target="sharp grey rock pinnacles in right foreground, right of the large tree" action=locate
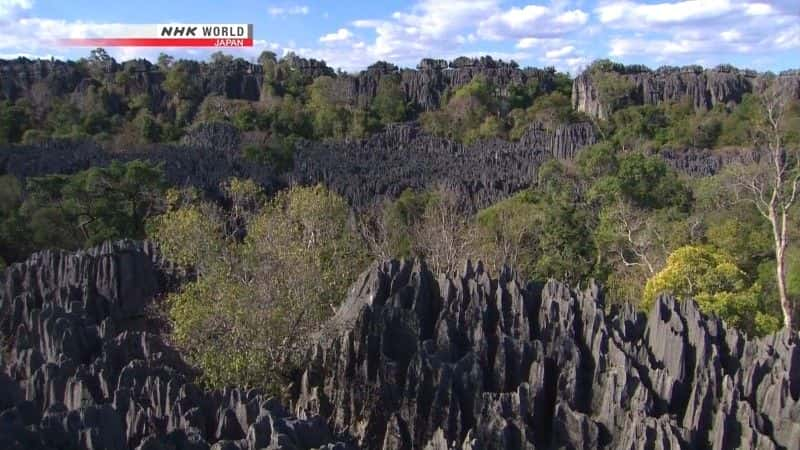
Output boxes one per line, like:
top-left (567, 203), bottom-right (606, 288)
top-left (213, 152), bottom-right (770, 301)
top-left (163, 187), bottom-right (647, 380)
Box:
top-left (294, 261), bottom-right (800, 450)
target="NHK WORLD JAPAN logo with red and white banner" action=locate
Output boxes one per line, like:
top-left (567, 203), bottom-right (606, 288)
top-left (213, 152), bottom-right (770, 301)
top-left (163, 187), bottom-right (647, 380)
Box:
top-left (59, 23), bottom-right (253, 47)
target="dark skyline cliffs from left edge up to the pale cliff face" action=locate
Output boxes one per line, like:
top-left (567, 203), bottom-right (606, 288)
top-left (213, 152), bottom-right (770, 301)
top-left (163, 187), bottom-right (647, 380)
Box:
top-left (0, 55), bottom-right (556, 113)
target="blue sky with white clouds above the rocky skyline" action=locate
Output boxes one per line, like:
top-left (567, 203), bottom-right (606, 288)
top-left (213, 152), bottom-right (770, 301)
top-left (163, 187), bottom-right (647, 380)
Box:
top-left (0, 0), bottom-right (800, 74)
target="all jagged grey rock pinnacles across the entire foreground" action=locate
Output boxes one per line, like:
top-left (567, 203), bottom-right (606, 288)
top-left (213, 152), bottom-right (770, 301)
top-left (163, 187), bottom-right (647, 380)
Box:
top-left (0, 241), bottom-right (800, 450)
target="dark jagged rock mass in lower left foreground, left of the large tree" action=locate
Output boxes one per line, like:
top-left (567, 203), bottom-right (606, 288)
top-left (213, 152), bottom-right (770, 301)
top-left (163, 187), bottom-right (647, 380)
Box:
top-left (0, 241), bottom-right (349, 450)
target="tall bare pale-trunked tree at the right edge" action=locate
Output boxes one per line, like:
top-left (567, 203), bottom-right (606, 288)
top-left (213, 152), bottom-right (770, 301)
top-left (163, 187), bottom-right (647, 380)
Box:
top-left (733, 81), bottom-right (800, 329)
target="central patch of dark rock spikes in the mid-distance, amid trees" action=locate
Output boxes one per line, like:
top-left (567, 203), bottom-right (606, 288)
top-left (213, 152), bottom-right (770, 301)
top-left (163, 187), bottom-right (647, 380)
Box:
top-left (289, 123), bottom-right (597, 209)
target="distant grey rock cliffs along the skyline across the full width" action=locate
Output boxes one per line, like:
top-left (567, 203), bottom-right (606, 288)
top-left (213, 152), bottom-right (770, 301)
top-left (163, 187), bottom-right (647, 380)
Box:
top-left (0, 55), bottom-right (800, 118)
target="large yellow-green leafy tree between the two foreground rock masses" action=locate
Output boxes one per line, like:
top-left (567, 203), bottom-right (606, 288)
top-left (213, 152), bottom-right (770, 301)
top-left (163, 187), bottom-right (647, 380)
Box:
top-left (149, 185), bottom-right (364, 393)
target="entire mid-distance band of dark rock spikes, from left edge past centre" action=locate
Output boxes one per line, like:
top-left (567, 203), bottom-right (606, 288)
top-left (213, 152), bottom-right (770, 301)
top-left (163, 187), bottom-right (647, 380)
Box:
top-left (0, 119), bottom-right (597, 209)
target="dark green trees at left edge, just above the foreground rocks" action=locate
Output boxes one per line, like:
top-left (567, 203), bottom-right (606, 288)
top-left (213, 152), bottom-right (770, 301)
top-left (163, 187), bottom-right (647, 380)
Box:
top-left (0, 161), bottom-right (165, 268)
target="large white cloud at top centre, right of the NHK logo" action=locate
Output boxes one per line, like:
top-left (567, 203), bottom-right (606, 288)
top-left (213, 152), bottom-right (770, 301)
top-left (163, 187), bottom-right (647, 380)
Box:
top-left (310, 0), bottom-right (590, 71)
